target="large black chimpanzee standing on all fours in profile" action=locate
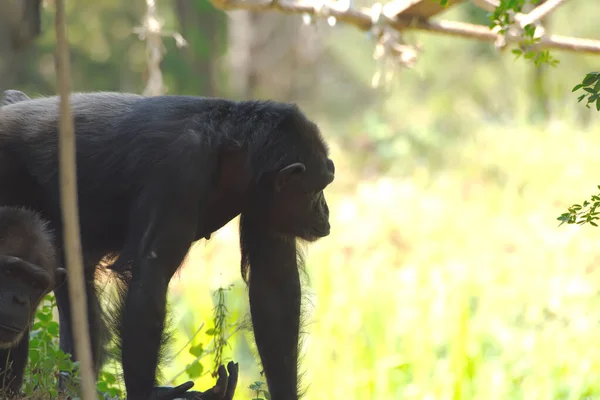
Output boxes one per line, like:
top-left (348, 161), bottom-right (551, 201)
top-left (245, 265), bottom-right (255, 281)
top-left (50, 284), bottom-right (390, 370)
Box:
top-left (0, 93), bottom-right (335, 400)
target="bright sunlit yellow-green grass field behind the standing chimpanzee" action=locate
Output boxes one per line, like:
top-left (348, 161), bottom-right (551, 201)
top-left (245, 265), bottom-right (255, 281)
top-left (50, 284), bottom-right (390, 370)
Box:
top-left (156, 114), bottom-right (600, 400)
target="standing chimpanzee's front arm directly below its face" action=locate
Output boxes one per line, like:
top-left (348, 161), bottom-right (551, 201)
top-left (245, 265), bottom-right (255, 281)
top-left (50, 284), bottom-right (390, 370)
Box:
top-left (240, 216), bottom-right (301, 400)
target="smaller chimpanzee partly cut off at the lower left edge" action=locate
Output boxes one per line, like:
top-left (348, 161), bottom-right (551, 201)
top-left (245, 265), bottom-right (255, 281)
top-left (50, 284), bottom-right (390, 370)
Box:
top-left (0, 207), bottom-right (66, 395)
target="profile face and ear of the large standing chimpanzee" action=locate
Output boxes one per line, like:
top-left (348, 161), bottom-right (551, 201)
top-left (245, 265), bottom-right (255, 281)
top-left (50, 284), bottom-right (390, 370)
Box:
top-left (269, 158), bottom-right (335, 242)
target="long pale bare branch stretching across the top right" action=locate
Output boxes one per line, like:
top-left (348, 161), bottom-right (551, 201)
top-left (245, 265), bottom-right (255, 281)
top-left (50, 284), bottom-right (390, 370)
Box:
top-left (211, 0), bottom-right (600, 54)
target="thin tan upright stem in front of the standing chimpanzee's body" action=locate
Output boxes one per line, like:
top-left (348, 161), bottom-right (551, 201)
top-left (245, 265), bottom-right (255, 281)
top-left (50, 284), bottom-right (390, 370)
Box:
top-left (55, 0), bottom-right (96, 400)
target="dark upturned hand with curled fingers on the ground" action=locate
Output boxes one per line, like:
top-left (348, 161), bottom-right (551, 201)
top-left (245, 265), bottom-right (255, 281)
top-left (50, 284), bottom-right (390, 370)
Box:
top-left (149, 361), bottom-right (239, 400)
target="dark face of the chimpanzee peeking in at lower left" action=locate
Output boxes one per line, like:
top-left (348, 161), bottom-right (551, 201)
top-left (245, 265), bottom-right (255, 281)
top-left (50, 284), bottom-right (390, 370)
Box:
top-left (0, 255), bottom-right (66, 348)
